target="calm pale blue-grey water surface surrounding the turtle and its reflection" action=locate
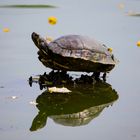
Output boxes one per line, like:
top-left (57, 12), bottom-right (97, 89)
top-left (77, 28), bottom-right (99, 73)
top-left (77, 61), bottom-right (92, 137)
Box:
top-left (0, 0), bottom-right (140, 140)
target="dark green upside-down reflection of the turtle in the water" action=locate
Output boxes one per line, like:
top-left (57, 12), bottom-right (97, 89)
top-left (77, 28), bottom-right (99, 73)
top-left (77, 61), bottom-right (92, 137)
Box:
top-left (30, 81), bottom-right (118, 131)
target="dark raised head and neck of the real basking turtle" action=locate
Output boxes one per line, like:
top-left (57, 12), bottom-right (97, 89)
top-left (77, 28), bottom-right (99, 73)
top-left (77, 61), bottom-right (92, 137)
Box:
top-left (31, 32), bottom-right (48, 50)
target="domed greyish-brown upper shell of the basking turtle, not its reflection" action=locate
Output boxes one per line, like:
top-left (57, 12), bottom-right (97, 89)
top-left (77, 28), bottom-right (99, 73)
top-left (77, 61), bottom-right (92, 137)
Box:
top-left (49, 35), bottom-right (117, 65)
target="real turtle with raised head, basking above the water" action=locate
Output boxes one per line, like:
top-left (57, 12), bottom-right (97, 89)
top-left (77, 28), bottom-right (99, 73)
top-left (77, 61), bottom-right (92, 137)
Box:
top-left (31, 32), bottom-right (118, 80)
